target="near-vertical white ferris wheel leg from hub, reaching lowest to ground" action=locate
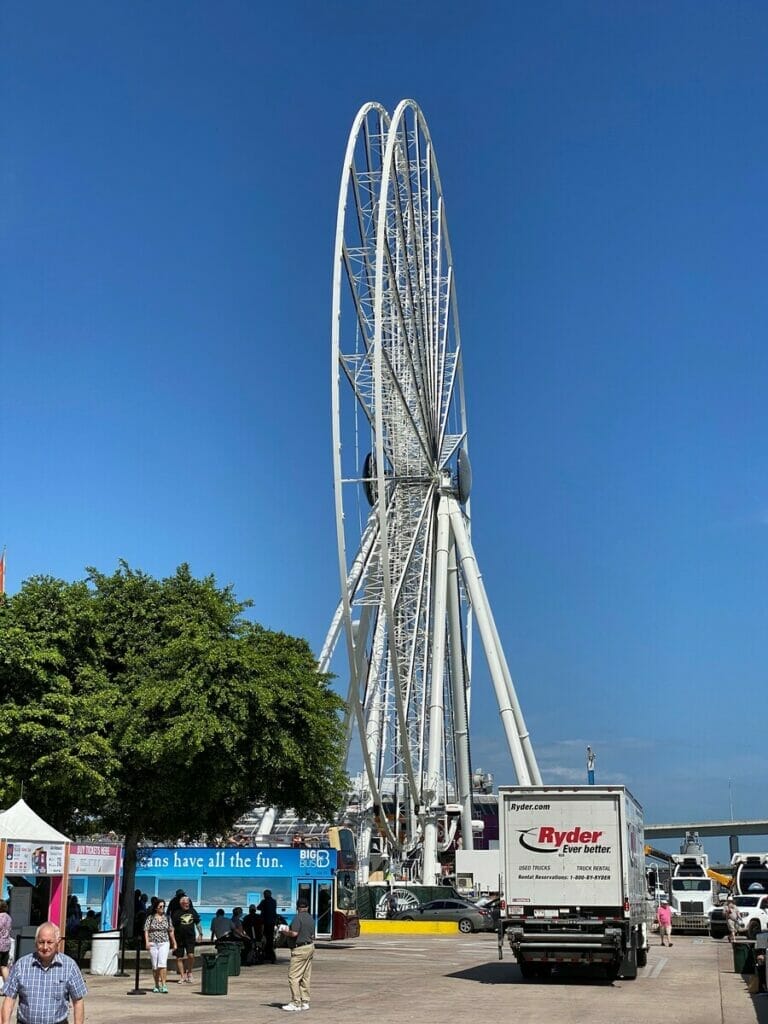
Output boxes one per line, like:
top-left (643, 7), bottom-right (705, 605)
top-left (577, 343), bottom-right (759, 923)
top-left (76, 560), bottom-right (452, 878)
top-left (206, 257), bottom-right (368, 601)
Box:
top-left (422, 495), bottom-right (451, 883)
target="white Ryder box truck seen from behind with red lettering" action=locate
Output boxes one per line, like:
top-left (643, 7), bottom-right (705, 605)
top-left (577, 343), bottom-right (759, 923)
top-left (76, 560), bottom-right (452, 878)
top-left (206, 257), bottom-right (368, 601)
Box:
top-left (499, 785), bottom-right (648, 980)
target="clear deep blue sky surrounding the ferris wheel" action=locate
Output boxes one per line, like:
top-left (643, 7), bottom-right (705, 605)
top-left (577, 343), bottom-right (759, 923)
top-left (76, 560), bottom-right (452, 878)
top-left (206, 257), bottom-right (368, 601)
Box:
top-left (0, 0), bottom-right (768, 855)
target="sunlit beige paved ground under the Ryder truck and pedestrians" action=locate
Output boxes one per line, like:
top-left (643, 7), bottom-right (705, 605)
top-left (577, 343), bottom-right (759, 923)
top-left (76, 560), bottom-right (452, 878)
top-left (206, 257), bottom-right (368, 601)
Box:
top-left (34, 935), bottom-right (768, 1024)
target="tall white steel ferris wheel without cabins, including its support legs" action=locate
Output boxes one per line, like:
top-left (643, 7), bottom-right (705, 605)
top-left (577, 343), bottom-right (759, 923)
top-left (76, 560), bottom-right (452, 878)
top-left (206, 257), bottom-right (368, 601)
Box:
top-left (319, 105), bottom-right (541, 882)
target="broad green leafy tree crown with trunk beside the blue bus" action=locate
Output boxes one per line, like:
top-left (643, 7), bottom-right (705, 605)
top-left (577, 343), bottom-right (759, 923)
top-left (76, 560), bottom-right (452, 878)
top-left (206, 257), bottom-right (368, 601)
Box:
top-left (0, 562), bottom-right (346, 918)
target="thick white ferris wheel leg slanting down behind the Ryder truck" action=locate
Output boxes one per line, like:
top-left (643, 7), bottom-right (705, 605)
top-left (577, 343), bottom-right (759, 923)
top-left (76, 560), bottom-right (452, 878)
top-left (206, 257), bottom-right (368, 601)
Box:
top-left (449, 499), bottom-right (531, 785)
